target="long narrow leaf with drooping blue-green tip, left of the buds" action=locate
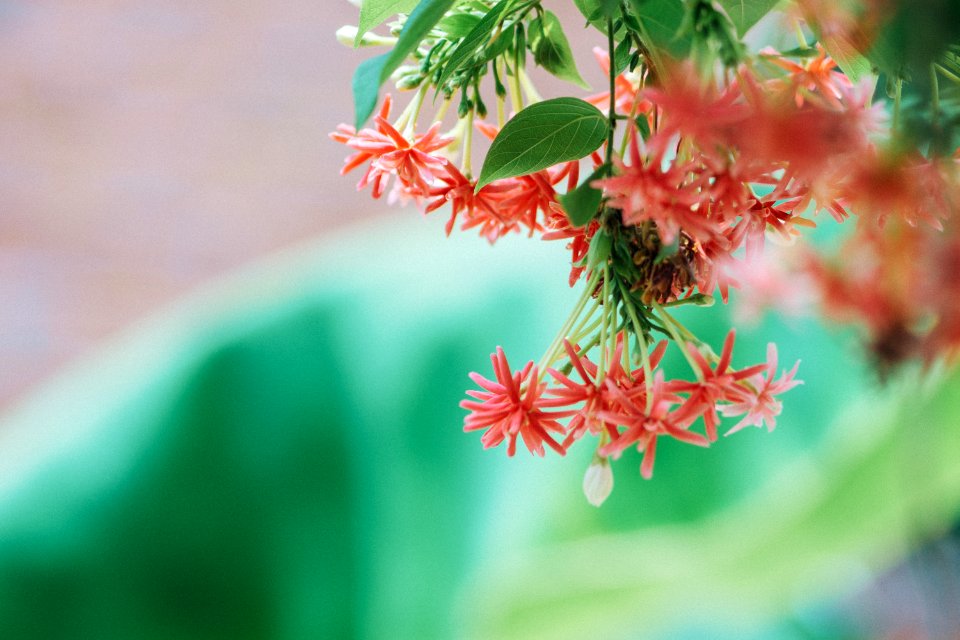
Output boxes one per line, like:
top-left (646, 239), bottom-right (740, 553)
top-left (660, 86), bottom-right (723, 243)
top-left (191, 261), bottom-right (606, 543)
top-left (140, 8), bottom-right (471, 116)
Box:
top-left (353, 0), bottom-right (456, 129)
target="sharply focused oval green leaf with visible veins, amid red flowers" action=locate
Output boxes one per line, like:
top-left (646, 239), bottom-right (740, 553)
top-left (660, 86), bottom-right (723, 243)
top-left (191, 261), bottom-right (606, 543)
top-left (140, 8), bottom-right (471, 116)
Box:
top-left (477, 98), bottom-right (607, 191)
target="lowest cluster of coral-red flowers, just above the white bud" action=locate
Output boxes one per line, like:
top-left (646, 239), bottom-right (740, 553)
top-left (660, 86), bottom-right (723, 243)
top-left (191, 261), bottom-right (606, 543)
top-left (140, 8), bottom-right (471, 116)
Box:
top-left (461, 331), bottom-right (801, 478)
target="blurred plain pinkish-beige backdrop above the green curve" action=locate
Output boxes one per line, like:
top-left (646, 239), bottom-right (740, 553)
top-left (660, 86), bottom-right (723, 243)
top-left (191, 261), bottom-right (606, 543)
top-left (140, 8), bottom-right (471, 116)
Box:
top-left (0, 0), bottom-right (600, 408)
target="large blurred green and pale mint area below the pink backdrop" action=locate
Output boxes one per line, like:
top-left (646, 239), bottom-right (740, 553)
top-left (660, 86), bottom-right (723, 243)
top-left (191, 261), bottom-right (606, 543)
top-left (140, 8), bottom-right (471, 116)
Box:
top-left (0, 216), bottom-right (960, 639)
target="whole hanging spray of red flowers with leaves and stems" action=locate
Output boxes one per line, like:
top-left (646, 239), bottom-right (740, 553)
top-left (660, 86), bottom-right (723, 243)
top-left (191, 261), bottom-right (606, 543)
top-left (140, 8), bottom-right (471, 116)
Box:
top-left (331, 0), bottom-right (960, 504)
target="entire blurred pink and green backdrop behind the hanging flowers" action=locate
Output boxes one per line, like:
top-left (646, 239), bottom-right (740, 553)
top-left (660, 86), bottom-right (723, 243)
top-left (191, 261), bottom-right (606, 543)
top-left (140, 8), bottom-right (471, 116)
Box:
top-left (0, 0), bottom-right (960, 638)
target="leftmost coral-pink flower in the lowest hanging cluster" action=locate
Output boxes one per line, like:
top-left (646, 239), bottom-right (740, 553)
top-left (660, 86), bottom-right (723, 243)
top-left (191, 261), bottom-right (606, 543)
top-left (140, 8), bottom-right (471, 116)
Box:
top-left (460, 347), bottom-right (576, 456)
